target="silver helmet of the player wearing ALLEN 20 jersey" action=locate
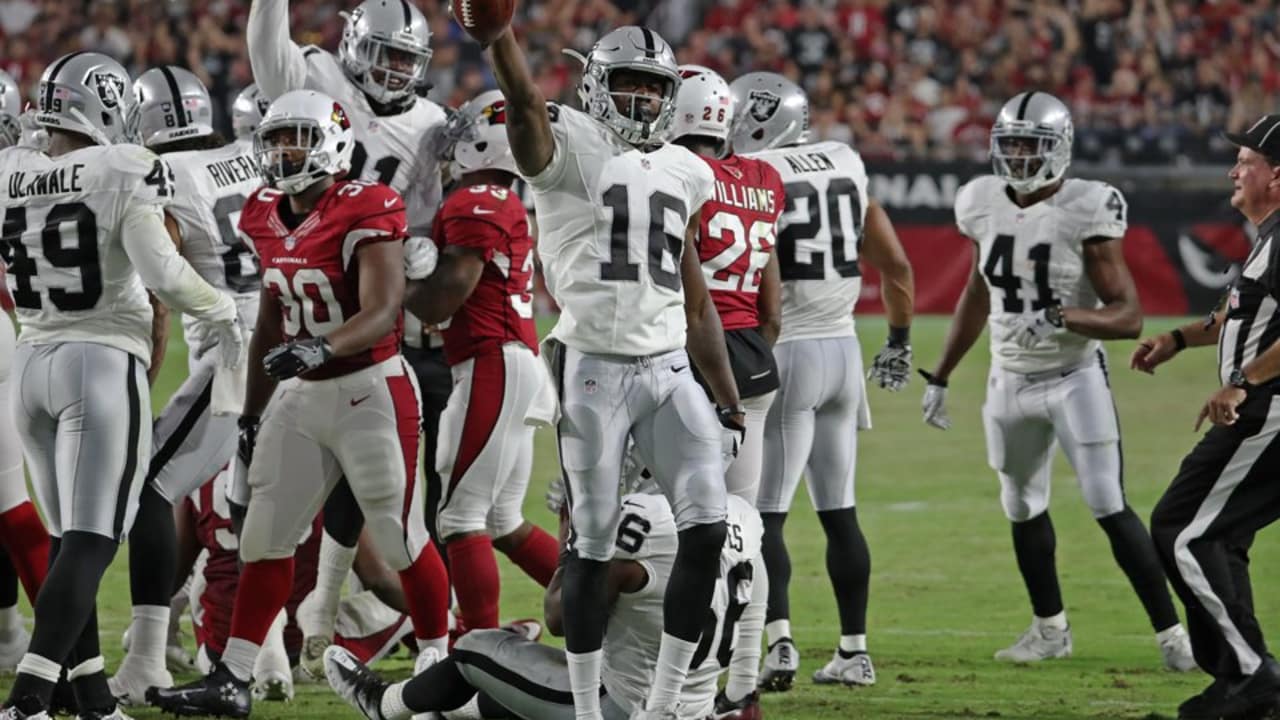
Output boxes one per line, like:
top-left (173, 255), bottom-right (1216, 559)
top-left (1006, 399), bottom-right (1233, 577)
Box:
top-left (728, 73), bottom-right (809, 152)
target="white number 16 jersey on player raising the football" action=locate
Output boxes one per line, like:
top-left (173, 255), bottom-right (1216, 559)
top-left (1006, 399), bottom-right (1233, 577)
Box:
top-left (526, 105), bottom-right (716, 357)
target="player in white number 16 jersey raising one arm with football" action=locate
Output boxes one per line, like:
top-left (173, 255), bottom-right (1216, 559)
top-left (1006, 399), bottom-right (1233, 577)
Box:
top-left (478, 26), bottom-right (746, 719)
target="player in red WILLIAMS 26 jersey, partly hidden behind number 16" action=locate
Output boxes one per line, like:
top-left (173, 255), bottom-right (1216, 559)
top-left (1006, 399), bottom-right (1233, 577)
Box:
top-left (671, 65), bottom-right (783, 506)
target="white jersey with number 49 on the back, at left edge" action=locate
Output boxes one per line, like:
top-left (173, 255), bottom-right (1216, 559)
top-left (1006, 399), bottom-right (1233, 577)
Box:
top-left (0, 145), bottom-right (174, 363)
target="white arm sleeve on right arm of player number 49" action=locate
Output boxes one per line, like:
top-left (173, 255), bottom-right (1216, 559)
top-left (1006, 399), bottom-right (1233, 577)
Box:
top-left (120, 197), bottom-right (236, 322)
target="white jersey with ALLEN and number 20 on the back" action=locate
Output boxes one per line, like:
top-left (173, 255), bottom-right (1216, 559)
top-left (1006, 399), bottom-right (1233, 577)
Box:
top-left (750, 142), bottom-right (868, 342)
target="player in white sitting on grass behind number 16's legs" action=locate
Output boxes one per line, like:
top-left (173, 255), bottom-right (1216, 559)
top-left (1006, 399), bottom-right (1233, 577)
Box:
top-left (325, 495), bottom-right (767, 720)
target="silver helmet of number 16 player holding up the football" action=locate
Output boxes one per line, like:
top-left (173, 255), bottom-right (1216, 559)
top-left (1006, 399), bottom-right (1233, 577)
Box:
top-left (577, 26), bottom-right (680, 147)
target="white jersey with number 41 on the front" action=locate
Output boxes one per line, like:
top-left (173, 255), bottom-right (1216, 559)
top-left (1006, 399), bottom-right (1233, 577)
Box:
top-left (956, 176), bottom-right (1128, 373)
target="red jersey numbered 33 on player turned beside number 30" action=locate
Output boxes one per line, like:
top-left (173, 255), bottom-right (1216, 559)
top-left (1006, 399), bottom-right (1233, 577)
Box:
top-left (434, 184), bottom-right (538, 365)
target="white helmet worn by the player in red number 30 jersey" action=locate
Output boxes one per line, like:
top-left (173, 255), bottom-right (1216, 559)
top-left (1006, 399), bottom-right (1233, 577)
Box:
top-left (253, 90), bottom-right (356, 195)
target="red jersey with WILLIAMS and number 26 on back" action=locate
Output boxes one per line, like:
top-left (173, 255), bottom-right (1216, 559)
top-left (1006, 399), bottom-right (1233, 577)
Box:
top-left (698, 155), bottom-right (786, 331)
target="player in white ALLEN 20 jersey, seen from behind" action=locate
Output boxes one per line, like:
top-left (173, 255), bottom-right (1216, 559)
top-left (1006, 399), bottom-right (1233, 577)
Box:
top-left (731, 73), bottom-right (914, 691)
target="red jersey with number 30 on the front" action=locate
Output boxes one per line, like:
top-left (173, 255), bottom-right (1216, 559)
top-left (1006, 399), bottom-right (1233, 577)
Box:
top-left (239, 181), bottom-right (408, 380)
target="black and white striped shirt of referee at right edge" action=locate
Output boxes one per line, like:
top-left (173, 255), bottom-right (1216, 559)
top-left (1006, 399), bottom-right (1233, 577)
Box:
top-left (1217, 210), bottom-right (1280, 384)
